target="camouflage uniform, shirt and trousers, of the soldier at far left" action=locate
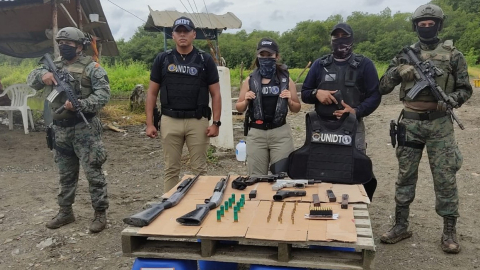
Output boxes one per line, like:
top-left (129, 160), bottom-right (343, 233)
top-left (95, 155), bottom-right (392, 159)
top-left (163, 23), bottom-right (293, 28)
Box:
top-left (27, 55), bottom-right (110, 211)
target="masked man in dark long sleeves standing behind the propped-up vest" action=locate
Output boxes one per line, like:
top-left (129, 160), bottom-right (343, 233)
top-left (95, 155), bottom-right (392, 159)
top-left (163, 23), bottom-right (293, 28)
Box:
top-left (302, 23), bottom-right (381, 199)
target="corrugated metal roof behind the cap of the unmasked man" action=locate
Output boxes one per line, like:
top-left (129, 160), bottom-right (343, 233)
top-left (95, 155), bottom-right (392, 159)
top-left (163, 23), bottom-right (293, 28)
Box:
top-left (145, 6), bottom-right (242, 31)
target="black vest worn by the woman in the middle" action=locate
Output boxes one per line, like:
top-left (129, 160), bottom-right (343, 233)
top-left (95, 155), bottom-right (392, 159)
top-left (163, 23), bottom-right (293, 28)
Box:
top-left (249, 69), bottom-right (290, 125)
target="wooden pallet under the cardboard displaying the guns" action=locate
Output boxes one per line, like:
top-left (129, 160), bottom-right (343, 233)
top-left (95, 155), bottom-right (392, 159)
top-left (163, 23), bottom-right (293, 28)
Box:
top-left (122, 204), bottom-right (375, 270)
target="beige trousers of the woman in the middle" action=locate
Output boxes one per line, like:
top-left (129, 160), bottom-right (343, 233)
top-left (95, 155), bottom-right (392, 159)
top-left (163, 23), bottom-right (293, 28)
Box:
top-left (247, 124), bottom-right (294, 175)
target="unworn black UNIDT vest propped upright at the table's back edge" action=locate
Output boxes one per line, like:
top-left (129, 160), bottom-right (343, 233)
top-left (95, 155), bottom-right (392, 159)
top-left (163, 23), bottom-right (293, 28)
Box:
top-left (288, 112), bottom-right (373, 184)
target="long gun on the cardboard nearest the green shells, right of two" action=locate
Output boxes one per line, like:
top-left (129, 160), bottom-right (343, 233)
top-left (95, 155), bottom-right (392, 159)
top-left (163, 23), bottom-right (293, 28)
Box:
top-left (177, 175), bottom-right (230, 226)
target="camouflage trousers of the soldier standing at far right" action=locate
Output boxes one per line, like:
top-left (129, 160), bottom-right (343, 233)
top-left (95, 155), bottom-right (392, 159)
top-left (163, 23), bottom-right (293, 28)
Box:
top-left (395, 117), bottom-right (463, 217)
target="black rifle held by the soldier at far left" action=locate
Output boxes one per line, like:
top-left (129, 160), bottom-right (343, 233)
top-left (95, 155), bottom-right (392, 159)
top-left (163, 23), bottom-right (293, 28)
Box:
top-left (40, 53), bottom-right (92, 128)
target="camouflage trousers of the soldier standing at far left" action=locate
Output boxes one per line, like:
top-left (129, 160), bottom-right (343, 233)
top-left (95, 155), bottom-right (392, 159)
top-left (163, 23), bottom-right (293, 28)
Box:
top-left (53, 117), bottom-right (108, 211)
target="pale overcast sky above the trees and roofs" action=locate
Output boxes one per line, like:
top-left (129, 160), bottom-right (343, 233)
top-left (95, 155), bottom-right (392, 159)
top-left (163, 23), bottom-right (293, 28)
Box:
top-left (100, 0), bottom-right (428, 40)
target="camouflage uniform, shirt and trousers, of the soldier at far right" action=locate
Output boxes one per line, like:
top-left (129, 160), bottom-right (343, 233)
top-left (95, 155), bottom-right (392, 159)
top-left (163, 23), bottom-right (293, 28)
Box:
top-left (380, 42), bottom-right (472, 217)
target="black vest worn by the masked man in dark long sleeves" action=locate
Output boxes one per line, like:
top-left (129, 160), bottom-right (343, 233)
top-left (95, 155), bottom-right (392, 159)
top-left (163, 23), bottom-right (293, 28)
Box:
top-left (315, 54), bottom-right (365, 117)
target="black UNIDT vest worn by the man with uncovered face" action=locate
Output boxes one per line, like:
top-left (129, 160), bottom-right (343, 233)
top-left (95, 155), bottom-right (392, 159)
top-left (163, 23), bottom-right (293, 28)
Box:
top-left (160, 50), bottom-right (209, 114)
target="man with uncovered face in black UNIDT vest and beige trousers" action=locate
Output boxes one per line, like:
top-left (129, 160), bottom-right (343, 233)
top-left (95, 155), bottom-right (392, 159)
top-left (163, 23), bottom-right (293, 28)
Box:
top-left (145, 17), bottom-right (222, 192)
